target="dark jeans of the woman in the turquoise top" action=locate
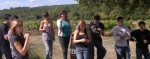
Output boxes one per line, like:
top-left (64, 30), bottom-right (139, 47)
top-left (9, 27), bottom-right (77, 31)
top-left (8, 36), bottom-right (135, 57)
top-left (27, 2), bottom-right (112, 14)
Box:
top-left (59, 36), bottom-right (70, 59)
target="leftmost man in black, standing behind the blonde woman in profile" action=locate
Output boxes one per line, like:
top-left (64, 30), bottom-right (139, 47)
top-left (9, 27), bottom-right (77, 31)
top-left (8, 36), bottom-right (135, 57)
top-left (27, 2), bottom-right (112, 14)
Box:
top-left (0, 14), bottom-right (12, 59)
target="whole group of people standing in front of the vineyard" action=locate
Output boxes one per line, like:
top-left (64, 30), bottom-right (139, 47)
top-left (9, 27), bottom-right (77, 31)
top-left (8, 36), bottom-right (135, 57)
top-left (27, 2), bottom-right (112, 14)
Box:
top-left (0, 11), bottom-right (150, 59)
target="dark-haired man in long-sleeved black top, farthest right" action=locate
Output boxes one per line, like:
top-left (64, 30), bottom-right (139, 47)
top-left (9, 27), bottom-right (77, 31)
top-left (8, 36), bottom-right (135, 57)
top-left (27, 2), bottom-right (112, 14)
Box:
top-left (131, 21), bottom-right (150, 59)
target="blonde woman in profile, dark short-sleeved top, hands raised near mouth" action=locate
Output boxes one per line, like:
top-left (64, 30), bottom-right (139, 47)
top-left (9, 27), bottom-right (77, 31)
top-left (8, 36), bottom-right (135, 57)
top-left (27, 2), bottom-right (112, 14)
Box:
top-left (10, 19), bottom-right (30, 59)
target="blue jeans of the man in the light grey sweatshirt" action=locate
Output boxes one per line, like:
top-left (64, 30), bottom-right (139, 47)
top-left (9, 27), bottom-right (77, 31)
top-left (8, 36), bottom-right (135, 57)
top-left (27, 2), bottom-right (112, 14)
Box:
top-left (115, 46), bottom-right (130, 59)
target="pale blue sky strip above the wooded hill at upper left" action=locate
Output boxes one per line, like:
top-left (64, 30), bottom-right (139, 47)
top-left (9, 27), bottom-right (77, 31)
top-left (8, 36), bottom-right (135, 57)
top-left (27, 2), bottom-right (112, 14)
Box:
top-left (0, 0), bottom-right (77, 10)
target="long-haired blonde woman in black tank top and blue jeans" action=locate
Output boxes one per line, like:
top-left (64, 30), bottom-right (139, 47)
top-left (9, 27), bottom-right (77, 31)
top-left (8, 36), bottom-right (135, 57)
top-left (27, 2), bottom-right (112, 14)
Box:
top-left (73, 21), bottom-right (91, 59)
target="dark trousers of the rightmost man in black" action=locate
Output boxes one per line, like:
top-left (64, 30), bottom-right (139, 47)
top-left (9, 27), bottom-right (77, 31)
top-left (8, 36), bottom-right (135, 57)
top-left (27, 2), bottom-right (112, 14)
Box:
top-left (136, 47), bottom-right (150, 59)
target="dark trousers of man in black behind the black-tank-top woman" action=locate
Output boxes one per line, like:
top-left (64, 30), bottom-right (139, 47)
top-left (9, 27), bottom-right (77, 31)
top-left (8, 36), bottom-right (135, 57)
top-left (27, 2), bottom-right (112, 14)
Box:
top-left (93, 37), bottom-right (106, 59)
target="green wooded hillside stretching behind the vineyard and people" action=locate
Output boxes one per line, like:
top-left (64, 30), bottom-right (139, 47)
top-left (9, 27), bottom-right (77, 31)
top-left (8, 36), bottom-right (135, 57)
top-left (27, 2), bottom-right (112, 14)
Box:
top-left (0, 4), bottom-right (150, 20)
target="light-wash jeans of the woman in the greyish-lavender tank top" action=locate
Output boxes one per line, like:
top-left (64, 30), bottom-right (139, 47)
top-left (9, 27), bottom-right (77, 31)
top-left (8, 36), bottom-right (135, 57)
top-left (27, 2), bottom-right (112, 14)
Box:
top-left (43, 40), bottom-right (53, 59)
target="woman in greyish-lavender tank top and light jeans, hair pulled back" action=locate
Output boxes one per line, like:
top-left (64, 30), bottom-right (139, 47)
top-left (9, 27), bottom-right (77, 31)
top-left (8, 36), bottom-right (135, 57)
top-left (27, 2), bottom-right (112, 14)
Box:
top-left (39, 12), bottom-right (55, 59)
